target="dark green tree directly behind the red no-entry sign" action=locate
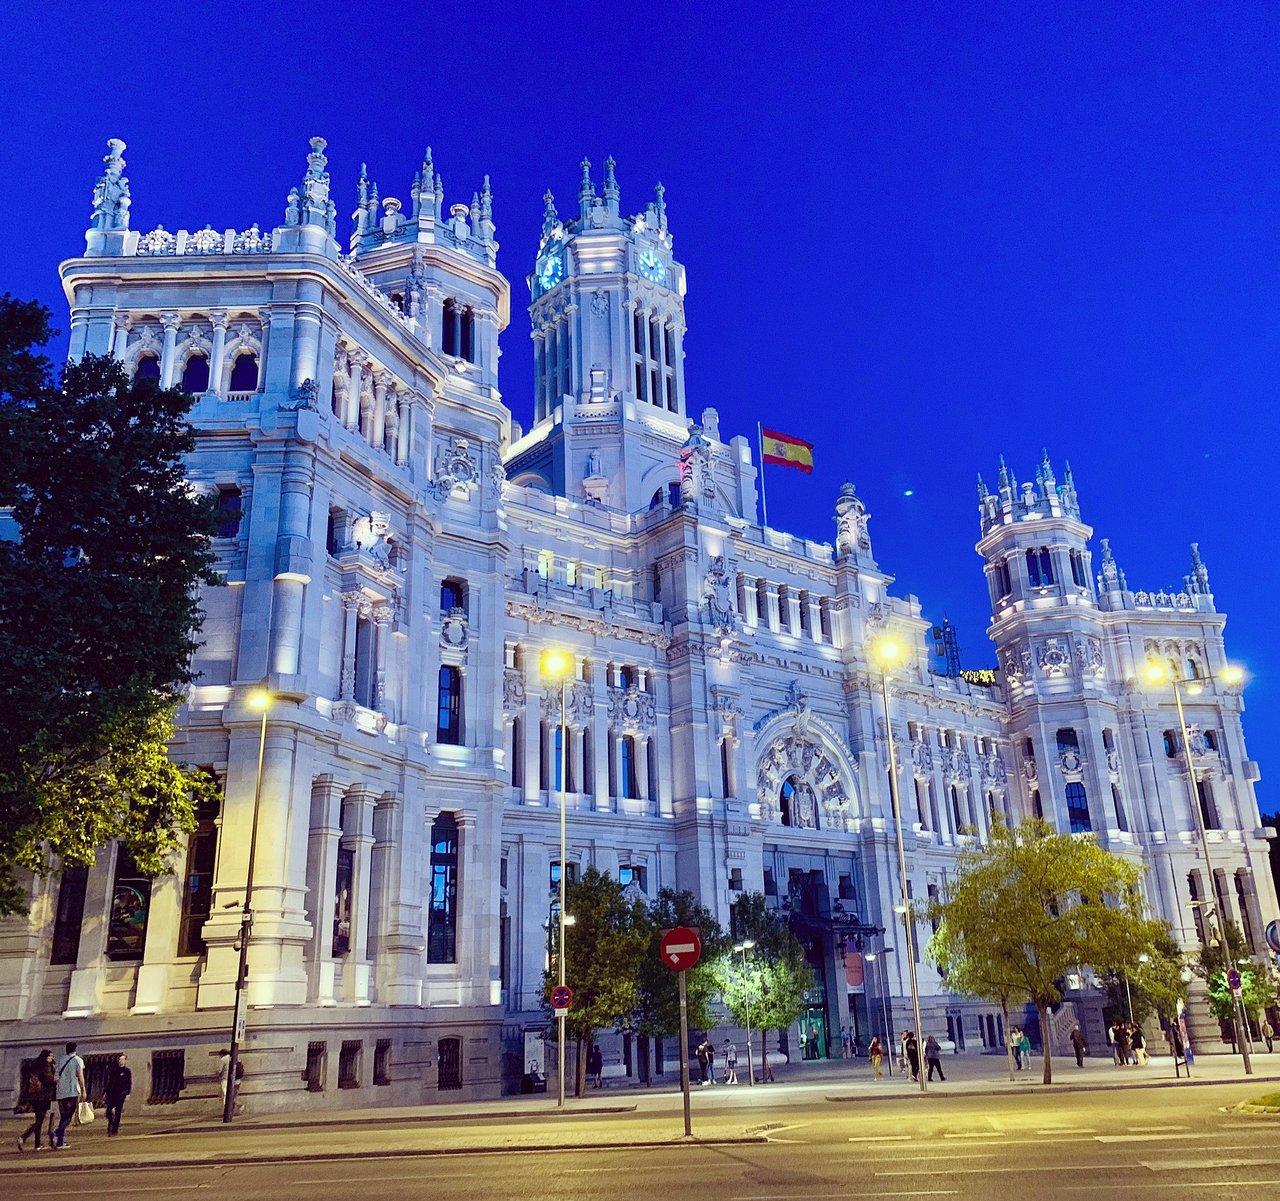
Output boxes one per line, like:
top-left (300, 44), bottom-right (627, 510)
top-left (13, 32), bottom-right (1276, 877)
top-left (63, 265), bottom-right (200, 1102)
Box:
top-left (632, 889), bottom-right (728, 1083)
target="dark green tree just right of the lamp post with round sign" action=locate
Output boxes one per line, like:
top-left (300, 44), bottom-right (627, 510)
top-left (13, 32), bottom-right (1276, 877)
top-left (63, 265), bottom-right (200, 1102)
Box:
top-left (543, 867), bottom-right (652, 1096)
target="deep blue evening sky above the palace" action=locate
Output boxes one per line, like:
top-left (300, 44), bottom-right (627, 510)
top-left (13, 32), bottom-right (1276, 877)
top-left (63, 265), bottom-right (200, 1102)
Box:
top-left (0, 7), bottom-right (1280, 808)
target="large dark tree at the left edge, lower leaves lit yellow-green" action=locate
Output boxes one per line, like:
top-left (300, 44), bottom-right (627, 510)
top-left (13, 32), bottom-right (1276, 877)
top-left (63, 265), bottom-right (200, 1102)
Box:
top-left (0, 296), bottom-right (215, 913)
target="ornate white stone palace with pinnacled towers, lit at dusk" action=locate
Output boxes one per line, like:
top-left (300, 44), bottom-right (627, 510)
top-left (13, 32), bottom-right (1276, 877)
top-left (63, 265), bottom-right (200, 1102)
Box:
top-left (0, 138), bottom-right (1277, 1110)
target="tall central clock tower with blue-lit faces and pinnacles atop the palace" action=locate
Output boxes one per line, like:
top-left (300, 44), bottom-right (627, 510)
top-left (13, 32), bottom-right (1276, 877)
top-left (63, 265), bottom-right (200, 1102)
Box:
top-left (507, 157), bottom-right (689, 511)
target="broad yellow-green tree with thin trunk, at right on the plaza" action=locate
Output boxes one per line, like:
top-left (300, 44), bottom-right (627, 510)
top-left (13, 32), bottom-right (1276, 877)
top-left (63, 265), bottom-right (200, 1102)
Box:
top-left (925, 821), bottom-right (1164, 1084)
